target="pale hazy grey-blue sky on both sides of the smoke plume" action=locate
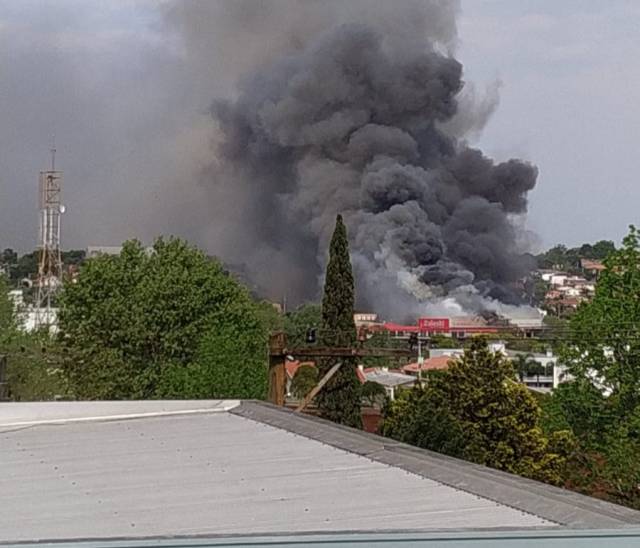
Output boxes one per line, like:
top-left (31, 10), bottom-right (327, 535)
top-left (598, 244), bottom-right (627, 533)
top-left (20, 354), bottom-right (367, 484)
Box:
top-left (0, 0), bottom-right (640, 251)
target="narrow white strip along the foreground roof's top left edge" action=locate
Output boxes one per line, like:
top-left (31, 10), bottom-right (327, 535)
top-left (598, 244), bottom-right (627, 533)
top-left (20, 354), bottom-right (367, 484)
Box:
top-left (0, 400), bottom-right (240, 431)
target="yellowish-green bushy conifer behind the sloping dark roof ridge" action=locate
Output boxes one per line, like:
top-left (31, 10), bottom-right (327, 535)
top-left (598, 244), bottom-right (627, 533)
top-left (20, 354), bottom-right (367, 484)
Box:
top-left (382, 339), bottom-right (570, 484)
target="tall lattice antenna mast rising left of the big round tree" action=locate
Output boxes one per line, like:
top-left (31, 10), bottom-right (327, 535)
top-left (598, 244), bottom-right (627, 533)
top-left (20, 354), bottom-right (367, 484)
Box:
top-left (35, 140), bottom-right (64, 328)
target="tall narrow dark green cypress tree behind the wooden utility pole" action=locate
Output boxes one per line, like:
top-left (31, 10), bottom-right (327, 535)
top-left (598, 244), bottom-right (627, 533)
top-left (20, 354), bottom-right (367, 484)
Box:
top-left (316, 215), bottom-right (362, 428)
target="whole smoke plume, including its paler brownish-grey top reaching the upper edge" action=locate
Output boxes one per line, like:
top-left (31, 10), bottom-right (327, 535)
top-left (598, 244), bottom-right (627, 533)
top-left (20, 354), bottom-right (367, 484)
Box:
top-left (167, 1), bottom-right (537, 318)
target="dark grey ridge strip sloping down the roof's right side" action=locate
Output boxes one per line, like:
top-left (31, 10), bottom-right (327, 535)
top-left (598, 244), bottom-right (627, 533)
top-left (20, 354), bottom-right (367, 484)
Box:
top-left (230, 401), bottom-right (640, 529)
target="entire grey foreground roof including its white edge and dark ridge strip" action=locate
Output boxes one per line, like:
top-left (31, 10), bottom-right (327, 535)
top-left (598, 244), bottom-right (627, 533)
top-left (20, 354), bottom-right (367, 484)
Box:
top-left (0, 401), bottom-right (640, 546)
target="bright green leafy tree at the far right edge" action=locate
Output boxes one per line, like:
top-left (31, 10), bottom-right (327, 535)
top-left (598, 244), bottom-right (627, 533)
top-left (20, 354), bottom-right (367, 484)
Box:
top-left (544, 227), bottom-right (640, 508)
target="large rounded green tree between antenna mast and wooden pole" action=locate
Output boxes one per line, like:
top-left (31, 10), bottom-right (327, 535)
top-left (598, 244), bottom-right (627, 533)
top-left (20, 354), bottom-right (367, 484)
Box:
top-left (60, 239), bottom-right (266, 399)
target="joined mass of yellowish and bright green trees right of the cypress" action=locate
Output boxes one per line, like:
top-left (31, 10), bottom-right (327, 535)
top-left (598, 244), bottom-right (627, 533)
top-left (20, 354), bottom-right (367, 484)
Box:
top-left (382, 227), bottom-right (640, 509)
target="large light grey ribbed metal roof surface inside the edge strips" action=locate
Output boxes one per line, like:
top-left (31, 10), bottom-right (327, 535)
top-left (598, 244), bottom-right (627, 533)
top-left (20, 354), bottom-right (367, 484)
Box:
top-left (0, 406), bottom-right (553, 541)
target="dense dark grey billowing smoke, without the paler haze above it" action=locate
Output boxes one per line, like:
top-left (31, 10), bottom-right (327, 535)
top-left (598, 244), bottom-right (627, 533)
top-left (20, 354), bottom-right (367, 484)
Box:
top-left (204, 9), bottom-right (537, 317)
